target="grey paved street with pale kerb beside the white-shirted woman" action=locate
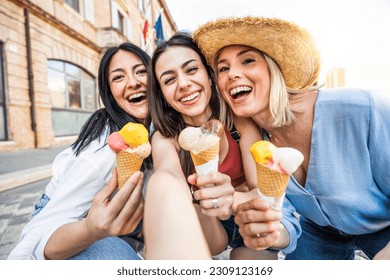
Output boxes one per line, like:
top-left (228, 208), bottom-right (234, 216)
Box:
top-left (0, 146), bottom-right (67, 260)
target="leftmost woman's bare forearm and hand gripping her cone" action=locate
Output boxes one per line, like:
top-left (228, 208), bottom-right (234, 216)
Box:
top-left (44, 172), bottom-right (144, 259)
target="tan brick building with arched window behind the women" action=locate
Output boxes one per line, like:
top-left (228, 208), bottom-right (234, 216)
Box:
top-left (0, 0), bottom-right (177, 152)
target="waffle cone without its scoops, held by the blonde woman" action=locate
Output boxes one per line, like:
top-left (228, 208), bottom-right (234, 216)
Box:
top-left (256, 162), bottom-right (290, 197)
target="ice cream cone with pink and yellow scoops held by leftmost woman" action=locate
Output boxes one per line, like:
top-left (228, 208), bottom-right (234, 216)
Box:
top-left (108, 122), bottom-right (151, 188)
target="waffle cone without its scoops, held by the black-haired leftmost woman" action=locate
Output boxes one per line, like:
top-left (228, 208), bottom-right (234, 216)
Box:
top-left (116, 150), bottom-right (143, 188)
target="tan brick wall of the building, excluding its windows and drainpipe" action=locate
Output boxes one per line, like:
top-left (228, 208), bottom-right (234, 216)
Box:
top-left (0, 0), bottom-right (176, 152)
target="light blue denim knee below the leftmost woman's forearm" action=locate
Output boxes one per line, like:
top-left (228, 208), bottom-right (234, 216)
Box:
top-left (68, 236), bottom-right (141, 260)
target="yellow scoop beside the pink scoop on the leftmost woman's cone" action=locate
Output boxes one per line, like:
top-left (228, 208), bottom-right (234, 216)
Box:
top-left (119, 122), bottom-right (149, 148)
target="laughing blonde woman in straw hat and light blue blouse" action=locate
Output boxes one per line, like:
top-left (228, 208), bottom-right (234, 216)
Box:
top-left (194, 17), bottom-right (390, 259)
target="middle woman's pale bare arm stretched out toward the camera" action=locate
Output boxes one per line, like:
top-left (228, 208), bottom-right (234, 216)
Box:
top-left (144, 171), bottom-right (211, 260)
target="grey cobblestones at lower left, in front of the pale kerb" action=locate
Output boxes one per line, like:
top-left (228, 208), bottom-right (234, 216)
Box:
top-left (0, 179), bottom-right (49, 260)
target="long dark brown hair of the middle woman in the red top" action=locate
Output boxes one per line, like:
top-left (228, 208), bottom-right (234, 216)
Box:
top-left (147, 31), bottom-right (232, 176)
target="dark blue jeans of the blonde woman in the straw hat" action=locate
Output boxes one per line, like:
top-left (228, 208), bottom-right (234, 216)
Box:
top-left (285, 216), bottom-right (390, 260)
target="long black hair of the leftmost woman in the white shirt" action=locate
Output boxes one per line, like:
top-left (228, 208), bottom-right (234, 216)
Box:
top-left (72, 42), bottom-right (150, 168)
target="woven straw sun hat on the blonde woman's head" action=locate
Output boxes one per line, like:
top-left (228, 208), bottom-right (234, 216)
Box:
top-left (193, 16), bottom-right (321, 89)
